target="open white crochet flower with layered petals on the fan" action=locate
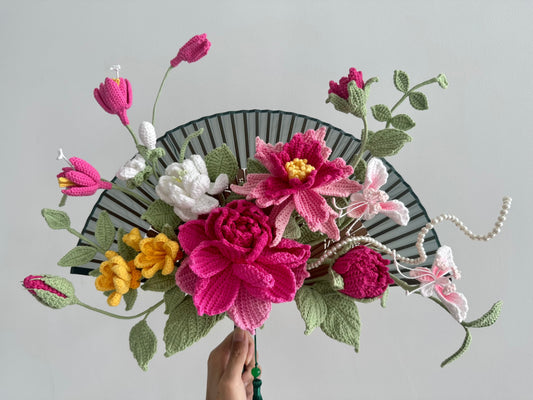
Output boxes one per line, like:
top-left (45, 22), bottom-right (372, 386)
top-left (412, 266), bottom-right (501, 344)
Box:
top-left (155, 155), bottom-right (229, 221)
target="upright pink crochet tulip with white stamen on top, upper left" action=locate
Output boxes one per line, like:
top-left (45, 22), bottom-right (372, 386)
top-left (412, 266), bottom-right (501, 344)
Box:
top-left (94, 78), bottom-right (132, 125)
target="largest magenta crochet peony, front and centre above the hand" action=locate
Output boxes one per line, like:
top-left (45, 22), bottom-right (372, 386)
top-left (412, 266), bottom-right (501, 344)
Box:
top-left (176, 200), bottom-right (310, 332)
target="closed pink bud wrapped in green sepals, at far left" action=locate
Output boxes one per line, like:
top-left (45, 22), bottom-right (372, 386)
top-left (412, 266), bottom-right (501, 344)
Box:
top-left (22, 275), bottom-right (78, 308)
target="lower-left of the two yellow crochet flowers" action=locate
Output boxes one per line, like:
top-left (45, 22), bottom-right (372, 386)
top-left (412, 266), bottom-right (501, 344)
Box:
top-left (94, 250), bottom-right (142, 307)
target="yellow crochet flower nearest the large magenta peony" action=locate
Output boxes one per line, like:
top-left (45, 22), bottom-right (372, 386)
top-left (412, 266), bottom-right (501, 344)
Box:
top-left (134, 233), bottom-right (183, 279)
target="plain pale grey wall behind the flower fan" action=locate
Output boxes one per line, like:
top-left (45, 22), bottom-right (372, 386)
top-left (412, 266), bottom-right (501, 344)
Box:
top-left (0, 0), bottom-right (533, 400)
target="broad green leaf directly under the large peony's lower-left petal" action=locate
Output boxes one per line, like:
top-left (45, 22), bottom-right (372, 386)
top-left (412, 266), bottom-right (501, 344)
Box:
top-left (163, 296), bottom-right (224, 357)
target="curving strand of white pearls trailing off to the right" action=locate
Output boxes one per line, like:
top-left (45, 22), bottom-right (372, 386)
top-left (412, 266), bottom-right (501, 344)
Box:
top-left (307, 196), bottom-right (512, 271)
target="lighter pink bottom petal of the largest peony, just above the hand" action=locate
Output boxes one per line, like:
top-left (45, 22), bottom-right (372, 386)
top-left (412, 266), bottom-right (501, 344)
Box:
top-left (228, 290), bottom-right (272, 334)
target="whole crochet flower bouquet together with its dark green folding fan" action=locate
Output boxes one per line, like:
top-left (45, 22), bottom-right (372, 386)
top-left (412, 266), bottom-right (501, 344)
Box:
top-left (23, 35), bottom-right (510, 372)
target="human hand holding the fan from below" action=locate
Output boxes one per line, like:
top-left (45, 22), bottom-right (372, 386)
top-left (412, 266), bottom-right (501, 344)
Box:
top-left (206, 328), bottom-right (255, 400)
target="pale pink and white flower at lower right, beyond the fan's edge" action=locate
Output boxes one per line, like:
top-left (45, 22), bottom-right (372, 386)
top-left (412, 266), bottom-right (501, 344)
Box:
top-left (410, 246), bottom-right (468, 322)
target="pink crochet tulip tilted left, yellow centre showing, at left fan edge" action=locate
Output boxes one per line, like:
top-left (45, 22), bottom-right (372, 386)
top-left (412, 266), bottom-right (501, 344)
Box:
top-left (57, 157), bottom-right (112, 196)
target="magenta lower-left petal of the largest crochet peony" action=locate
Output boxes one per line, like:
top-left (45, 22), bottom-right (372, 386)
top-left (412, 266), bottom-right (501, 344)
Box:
top-left (193, 269), bottom-right (241, 315)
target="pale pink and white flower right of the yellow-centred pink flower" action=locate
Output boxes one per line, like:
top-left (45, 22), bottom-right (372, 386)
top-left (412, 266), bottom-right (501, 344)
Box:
top-left (348, 158), bottom-right (409, 225)
